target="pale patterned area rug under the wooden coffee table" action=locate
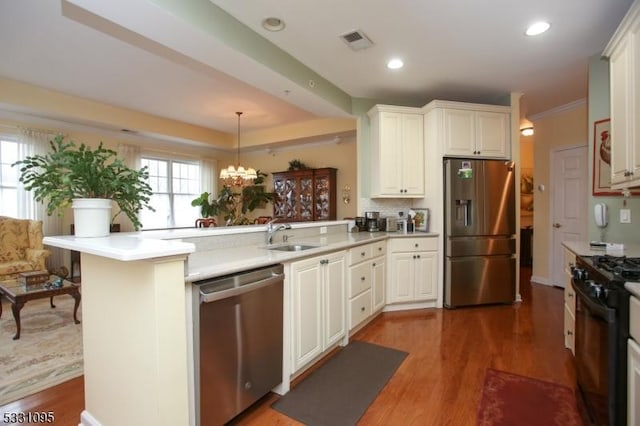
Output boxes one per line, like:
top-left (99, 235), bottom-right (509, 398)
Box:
top-left (0, 295), bottom-right (83, 405)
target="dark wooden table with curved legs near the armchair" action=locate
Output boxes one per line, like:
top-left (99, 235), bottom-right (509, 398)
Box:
top-left (0, 275), bottom-right (80, 340)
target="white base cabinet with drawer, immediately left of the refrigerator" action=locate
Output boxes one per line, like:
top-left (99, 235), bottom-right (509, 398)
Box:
top-left (387, 237), bottom-right (438, 303)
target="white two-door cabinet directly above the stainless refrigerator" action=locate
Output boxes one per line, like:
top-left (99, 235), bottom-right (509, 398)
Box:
top-left (436, 101), bottom-right (511, 158)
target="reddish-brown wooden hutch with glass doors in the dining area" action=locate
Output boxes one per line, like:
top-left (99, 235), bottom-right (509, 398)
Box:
top-left (273, 168), bottom-right (337, 222)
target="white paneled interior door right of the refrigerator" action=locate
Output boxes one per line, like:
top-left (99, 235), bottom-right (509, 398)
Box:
top-left (549, 146), bottom-right (591, 287)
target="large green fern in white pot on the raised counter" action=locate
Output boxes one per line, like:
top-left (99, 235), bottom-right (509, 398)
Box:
top-left (13, 135), bottom-right (153, 237)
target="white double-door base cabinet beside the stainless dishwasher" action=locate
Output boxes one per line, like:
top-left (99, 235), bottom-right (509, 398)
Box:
top-left (290, 251), bottom-right (346, 372)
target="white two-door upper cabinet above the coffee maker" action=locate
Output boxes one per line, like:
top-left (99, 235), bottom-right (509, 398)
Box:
top-left (368, 105), bottom-right (424, 198)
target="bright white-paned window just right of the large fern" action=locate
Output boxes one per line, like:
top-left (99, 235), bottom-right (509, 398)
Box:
top-left (140, 157), bottom-right (200, 229)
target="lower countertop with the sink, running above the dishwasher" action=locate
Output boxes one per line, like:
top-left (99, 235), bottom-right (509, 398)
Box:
top-left (185, 232), bottom-right (438, 282)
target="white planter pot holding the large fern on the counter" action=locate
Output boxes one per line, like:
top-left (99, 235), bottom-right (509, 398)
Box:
top-left (71, 198), bottom-right (111, 238)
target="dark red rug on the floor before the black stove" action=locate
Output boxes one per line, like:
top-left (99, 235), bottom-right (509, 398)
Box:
top-left (478, 368), bottom-right (583, 426)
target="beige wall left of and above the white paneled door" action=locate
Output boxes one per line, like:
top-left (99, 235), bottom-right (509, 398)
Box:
top-left (532, 103), bottom-right (589, 282)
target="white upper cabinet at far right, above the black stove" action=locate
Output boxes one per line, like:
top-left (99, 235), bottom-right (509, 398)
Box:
top-left (596, 2), bottom-right (640, 189)
